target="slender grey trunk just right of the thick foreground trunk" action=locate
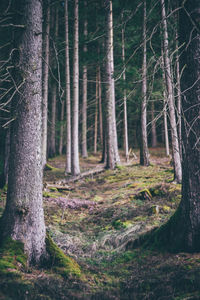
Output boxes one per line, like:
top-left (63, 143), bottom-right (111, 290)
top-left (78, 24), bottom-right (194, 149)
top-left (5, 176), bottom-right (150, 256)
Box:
top-left (42, 0), bottom-right (50, 167)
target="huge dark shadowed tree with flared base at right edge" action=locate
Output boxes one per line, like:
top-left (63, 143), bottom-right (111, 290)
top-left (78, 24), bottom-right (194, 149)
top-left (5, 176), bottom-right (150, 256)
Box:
top-left (149, 0), bottom-right (200, 252)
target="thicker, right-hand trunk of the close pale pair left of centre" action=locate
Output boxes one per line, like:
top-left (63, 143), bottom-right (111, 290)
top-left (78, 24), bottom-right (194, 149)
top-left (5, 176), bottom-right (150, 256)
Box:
top-left (72, 0), bottom-right (80, 176)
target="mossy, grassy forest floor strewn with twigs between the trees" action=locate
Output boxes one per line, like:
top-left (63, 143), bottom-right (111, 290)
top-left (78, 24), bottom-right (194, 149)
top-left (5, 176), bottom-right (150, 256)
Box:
top-left (0, 148), bottom-right (200, 300)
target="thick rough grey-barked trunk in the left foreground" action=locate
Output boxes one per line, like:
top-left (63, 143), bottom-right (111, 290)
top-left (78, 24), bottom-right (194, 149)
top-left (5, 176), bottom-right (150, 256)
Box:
top-left (1, 0), bottom-right (46, 263)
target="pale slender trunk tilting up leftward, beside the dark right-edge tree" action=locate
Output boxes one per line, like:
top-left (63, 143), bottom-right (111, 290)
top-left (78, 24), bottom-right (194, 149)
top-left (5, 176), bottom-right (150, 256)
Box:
top-left (161, 0), bottom-right (182, 183)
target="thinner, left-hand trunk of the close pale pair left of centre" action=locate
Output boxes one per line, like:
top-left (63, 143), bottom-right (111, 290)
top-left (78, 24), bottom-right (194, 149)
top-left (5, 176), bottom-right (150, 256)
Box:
top-left (65, 0), bottom-right (72, 174)
